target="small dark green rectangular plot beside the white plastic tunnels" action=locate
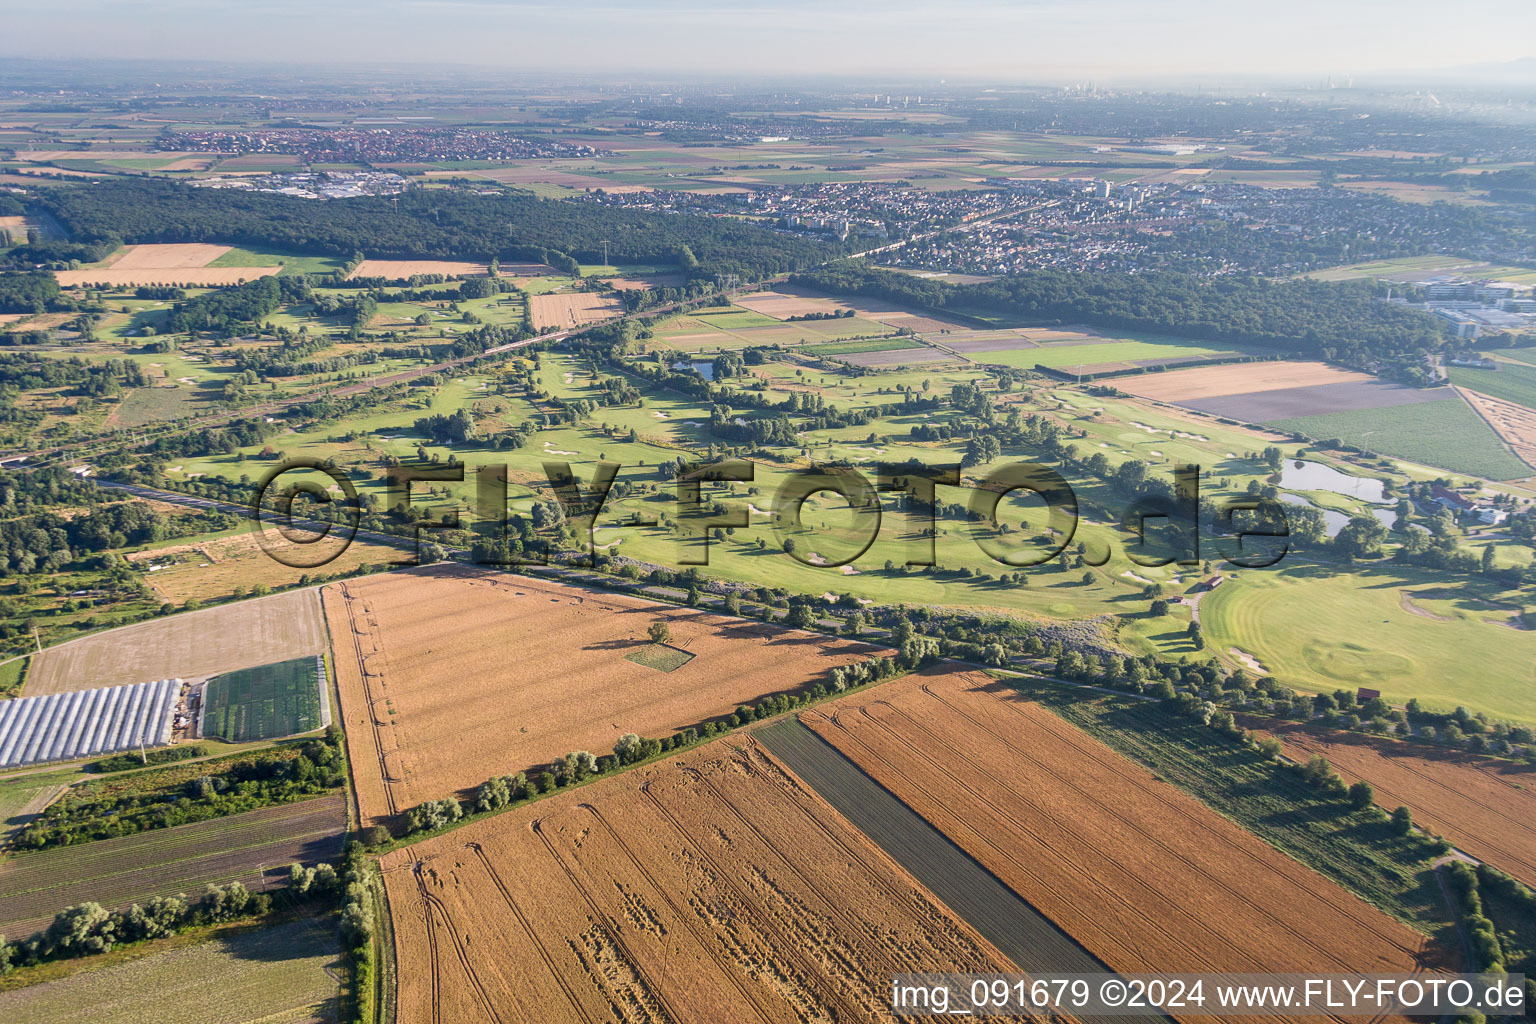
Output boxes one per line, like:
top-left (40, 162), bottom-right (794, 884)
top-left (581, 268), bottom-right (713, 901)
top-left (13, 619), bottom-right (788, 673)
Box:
top-left (203, 657), bottom-right (324, 743)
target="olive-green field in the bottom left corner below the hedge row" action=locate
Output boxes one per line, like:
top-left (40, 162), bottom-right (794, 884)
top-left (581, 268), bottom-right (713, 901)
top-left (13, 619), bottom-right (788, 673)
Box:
top-left (0, 918), bottom-right (343, 1024)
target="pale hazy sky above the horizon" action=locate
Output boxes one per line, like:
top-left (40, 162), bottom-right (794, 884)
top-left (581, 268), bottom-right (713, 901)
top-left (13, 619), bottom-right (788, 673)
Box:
top-left (0, 0), bottom-right (1536, 81)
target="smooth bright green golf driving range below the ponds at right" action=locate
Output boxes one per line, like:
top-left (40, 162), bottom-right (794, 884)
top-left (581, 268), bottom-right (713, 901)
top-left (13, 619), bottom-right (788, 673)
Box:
top-left (1200, 563), bottom-right (1536, 723)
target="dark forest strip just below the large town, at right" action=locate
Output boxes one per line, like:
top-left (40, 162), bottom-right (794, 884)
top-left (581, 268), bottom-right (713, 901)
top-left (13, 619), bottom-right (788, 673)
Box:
top-left (791, 263), bottom-right (1442, 382)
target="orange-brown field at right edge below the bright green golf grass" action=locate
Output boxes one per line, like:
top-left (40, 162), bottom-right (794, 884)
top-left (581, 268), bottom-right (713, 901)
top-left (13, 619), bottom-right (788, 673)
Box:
top-left (1256, 722), bottom-right (1536, 886)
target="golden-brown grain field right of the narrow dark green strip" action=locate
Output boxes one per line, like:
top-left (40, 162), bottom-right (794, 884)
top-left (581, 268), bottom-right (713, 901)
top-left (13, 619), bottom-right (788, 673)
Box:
top-left (800, 666), bottom-right (1427, 1019)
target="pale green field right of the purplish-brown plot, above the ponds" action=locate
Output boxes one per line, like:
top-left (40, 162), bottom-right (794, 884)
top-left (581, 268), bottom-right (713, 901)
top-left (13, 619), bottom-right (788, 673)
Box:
top-left (1264, 399), bottom-right (1531, 481)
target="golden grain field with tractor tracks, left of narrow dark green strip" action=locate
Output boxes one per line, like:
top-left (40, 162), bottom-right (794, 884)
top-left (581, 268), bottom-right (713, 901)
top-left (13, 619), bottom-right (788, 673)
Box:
top-left (382, 738), bottom-right (1014, 1024)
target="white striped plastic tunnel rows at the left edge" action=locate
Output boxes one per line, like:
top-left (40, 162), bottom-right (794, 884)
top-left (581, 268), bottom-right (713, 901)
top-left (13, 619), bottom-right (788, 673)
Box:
top-left (0, 679), bottom-right (181, 768)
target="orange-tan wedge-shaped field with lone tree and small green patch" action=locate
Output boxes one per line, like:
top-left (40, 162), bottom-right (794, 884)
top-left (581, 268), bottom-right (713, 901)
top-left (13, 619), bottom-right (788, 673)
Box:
top-left (323, 567), bottom-right (879, 823)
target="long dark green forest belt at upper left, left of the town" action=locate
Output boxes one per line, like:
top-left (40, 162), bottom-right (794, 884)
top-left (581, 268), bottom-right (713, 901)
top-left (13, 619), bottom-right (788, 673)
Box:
top-left (29, 180), bottom-right (839, 279)
